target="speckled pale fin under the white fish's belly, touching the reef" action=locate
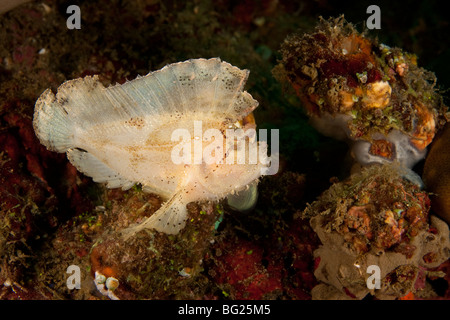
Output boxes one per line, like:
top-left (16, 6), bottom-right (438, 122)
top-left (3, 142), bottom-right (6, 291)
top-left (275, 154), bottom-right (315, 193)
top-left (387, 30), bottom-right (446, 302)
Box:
top-left (123, 191), bottom-right (188, 239)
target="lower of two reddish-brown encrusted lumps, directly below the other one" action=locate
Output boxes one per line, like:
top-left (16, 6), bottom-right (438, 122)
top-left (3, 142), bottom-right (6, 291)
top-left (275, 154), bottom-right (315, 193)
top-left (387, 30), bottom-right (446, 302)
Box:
top-left (303, 165), bottom-right (450, 299)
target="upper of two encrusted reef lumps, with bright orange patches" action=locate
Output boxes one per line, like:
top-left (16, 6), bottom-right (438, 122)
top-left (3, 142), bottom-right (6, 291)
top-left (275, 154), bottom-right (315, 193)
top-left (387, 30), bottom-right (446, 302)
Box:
top-left (274, 16), bottom-right (447, 167)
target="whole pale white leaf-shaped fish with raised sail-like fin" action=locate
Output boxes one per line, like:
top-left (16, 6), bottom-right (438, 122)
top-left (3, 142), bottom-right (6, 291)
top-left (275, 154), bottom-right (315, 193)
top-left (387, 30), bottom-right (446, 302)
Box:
top-left (33, 58), bottom-right (270, 237)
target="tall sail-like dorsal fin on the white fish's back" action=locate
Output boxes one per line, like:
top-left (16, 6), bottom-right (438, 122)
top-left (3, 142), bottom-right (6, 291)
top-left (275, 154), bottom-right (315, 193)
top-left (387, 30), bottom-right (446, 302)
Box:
top-left (106, 58), bottom-right (258, 121)
